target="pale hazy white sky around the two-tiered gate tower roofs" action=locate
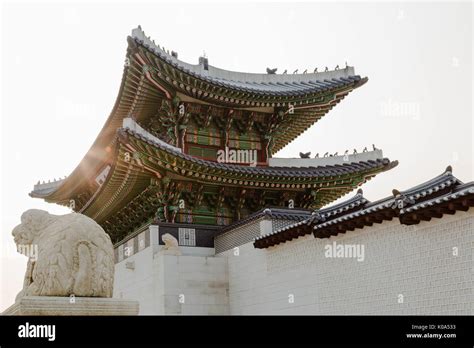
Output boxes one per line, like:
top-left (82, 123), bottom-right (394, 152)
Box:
top-left (0, 1), bottom-right (474, 311)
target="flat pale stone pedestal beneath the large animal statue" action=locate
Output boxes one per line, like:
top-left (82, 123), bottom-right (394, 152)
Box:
top-left (2, 296), bottom-right (138, 315)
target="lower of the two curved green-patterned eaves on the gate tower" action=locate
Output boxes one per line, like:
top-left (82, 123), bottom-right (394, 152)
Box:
top-left (70, 129), bottom-right (397, 221)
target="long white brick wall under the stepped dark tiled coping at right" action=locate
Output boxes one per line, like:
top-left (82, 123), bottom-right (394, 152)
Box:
top-left (219, 208), bottom-right (474, 315)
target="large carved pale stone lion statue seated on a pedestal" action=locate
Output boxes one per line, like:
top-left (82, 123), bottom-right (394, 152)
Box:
top-left (12, 209), bottom-right (114, 300)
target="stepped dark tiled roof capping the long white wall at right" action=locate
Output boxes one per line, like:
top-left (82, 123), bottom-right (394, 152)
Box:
top-left (254, 166), bottom-right (474, 248)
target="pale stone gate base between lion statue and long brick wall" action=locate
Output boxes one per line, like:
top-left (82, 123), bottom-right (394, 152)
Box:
top-left (114, 245), bottom-right (229, 315)
